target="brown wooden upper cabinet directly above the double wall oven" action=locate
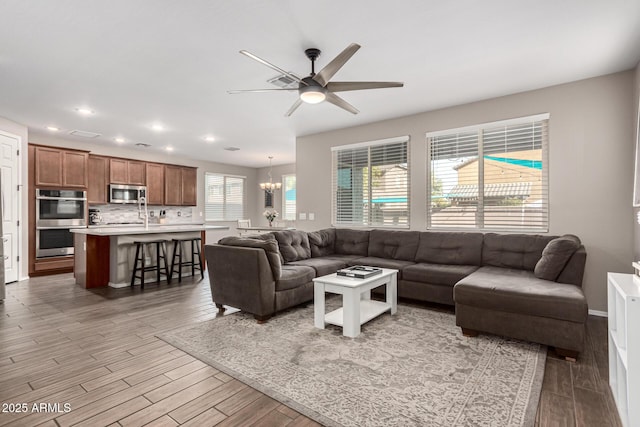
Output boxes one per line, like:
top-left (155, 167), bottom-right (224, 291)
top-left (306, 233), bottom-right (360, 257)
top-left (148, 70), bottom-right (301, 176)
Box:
top-left (35, 146), bottom-right (89, 188)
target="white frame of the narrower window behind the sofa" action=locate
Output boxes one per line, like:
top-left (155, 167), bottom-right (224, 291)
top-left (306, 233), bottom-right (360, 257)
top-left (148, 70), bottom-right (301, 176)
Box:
top-left (331, 135), bottom-right (411, 229)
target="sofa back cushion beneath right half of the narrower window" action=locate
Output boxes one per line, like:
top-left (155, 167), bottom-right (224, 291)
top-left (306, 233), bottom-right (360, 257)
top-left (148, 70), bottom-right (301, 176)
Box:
top-left (368, 230), bottom-right (420, 261)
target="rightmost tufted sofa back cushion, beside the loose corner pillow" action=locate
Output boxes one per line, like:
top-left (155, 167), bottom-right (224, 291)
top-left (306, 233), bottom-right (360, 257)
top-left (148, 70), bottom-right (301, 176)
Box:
top-left (482, 233), bottom-right (557, 271)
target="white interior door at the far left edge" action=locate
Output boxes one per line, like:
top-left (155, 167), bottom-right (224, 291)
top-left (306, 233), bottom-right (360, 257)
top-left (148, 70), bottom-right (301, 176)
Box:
top-left (0, 131), bottom-right (20, 283)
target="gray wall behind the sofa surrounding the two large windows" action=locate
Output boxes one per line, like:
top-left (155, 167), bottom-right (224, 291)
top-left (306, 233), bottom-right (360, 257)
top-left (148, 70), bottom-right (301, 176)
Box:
top-left (296, 71), bottom-right (635, 311)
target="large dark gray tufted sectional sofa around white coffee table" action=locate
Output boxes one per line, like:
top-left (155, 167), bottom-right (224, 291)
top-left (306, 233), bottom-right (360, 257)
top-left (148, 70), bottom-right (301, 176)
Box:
top-left (205, 228), bottom-right (588, 358)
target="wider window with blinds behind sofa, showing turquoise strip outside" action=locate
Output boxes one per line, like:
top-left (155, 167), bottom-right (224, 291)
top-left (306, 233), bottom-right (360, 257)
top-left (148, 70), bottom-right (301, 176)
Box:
top-left (427, 114), bottom-right (549, 231)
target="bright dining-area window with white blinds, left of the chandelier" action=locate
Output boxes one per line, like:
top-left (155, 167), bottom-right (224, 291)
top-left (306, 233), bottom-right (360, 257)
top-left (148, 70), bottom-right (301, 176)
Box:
top-left (204, 173), bottom-right (245, 221)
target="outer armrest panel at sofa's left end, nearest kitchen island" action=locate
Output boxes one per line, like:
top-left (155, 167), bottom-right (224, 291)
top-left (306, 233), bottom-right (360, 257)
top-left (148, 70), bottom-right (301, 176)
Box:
top-left (205, 244), bottom-right (275, 316)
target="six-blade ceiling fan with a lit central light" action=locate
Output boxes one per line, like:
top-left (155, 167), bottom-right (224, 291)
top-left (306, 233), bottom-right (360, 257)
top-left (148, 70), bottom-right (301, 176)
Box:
top-left (228, 43), bottom-right (404, 117)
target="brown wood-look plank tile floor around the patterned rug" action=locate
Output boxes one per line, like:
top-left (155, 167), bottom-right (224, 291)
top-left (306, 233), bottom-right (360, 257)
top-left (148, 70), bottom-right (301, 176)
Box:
top-left (0, 274), bottom-right (620, 427)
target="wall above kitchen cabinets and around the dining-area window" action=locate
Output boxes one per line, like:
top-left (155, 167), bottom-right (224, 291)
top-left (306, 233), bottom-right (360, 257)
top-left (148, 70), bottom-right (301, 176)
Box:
top-left (25, 134), bottom-right (258, 243)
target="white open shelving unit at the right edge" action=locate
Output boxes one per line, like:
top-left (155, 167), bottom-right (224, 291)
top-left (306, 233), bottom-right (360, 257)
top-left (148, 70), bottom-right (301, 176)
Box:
top-left (607, 272), bottom-right (640, 427)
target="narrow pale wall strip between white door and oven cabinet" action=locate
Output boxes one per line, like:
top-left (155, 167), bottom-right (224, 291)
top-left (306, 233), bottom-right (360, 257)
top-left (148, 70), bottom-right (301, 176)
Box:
top-left (0, 117), bottom-right (29, 280)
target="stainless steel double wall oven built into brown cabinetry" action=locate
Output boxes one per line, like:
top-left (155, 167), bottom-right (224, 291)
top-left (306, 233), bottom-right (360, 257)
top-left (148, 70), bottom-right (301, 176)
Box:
top-left (36, 188), bottom-right (87, 258)
